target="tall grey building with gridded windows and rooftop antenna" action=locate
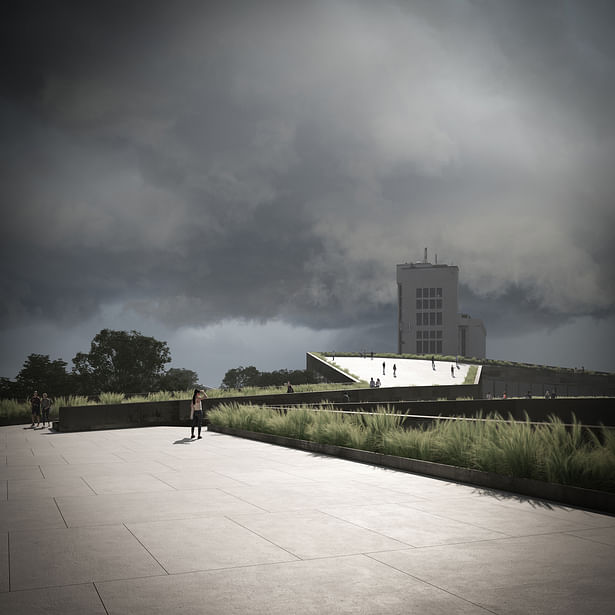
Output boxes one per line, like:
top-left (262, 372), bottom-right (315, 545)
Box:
top-left (397, 250), bottom-right (487, 358)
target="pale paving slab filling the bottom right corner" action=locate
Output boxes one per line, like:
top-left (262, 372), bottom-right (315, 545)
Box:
top-left (373, 534), bottom-right (615, 615)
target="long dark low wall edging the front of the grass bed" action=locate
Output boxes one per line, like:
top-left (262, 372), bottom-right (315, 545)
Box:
top-left (208, 425), bottom-right (615, 513)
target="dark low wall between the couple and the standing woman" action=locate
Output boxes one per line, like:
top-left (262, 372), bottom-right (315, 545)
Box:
top-left (58, 399), bottom-right (190, 431)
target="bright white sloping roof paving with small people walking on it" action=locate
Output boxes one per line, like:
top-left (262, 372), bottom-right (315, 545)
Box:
top-left (326, 355), bottom-right (470, 387)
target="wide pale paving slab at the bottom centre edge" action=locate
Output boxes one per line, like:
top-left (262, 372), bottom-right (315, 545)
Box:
top-left (97, 555), bottom-right (487, 615)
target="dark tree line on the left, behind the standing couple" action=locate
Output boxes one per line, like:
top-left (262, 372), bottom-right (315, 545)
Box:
top-left (0, 329), bottom-right (198, 399)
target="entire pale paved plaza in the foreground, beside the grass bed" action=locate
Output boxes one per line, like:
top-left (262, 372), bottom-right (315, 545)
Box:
top-left (0, 426), bottom-right (615, 615)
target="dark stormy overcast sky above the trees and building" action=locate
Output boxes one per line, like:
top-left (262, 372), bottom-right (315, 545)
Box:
top-left (0, 0), bottom-right (615, 385)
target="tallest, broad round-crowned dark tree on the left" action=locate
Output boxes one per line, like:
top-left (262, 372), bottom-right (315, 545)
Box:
top-left (73, 329), bottom-right (171, 393)
